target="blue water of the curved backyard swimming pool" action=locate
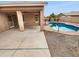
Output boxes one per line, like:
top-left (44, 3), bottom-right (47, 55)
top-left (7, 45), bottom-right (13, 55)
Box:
top-left (49, 22), bottom-right (79, 32)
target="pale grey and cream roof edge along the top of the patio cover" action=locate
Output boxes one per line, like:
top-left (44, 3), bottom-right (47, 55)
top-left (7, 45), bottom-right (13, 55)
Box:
top-left (0, 2), bottom-right (47, 7)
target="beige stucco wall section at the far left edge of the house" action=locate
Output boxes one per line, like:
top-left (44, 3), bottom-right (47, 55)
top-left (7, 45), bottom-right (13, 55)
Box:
top-left (0, 13), bottom-right (9, 32)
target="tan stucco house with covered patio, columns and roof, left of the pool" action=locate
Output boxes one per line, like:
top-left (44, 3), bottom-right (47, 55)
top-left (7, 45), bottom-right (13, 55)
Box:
top-left (0, 2), bottom-right (47, 32)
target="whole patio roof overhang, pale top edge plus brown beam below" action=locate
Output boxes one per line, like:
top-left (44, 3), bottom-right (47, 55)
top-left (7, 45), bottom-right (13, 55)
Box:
top-left (0, 2), bottom-right (47, 12)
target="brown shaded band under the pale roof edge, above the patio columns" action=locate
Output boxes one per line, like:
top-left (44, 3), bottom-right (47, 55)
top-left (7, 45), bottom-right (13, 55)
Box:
top-left (0, 6), bottom-right (43, 12)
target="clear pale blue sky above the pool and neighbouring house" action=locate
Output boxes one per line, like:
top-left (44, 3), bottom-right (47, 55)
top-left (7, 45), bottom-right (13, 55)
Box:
top-left (44, 1), bottom-right (79, 16)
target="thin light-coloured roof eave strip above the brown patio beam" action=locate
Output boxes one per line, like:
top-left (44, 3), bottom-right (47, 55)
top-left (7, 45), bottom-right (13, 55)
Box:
top-left (0, 2), bottom-right (48, 7)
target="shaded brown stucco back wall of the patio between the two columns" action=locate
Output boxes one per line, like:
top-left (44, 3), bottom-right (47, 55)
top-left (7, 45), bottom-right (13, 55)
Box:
top-left (23, 13), bottom-right (37, 27)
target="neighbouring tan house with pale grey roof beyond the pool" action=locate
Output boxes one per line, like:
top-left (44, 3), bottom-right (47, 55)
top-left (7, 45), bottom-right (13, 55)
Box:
top-left (60, 11), bottom-right (79, 23)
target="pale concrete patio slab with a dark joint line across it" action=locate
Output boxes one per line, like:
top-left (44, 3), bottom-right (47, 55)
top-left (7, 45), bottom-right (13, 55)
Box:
top-left (0, 27), bottom-right (50, 57)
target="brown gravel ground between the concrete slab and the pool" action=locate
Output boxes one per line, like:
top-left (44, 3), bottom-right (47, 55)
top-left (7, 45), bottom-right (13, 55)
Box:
top-left (44, 30), bottom-right (79, 57)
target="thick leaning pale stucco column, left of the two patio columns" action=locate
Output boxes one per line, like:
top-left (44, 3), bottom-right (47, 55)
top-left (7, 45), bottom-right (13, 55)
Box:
top-left (16, 11), bottom-right (24, 31)
